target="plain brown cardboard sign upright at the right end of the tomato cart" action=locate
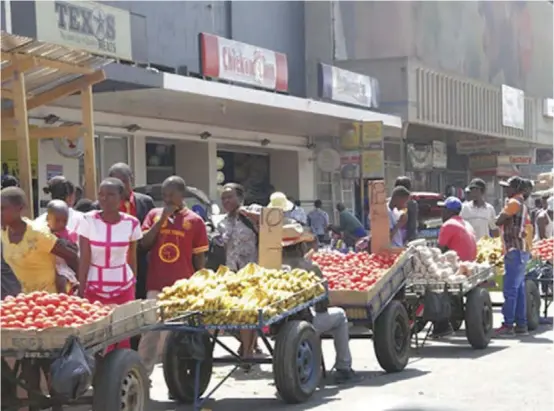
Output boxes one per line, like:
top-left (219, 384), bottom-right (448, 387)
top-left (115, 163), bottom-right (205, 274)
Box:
top-left (367, 180), bottom-right (390, 253)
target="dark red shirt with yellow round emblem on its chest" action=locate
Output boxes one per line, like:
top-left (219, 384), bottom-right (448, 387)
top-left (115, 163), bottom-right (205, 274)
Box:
top-left (142, 208), bottom-right (209, 291)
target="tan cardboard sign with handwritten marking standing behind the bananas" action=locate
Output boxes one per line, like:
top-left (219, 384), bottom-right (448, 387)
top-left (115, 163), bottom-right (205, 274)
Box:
top-left (258, 207), bottom-right (283, 270)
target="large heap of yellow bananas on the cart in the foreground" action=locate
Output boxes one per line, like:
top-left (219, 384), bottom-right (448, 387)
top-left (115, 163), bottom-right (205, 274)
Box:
top-left (158, 264), bottom-right (325, 325)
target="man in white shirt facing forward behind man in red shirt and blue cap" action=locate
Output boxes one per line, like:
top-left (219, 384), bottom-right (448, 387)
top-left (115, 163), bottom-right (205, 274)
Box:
top-left (460, 178), bottom-right (498, 241)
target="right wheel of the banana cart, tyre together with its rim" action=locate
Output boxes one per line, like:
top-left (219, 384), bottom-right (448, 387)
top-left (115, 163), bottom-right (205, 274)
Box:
top-left (273, 321), bottom-right (321, 404)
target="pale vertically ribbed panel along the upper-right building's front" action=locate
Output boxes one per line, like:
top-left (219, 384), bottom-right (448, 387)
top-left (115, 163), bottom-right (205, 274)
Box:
top-left (412, 67), bottom-right (535, 141)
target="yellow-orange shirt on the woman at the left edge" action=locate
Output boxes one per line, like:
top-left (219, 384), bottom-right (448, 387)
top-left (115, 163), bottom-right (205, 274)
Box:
top-left (2, 219), bottom-right (57, 293)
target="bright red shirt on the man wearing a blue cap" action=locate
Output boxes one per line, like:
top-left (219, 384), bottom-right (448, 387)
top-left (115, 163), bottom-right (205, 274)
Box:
top-left (438, 216), bottom-right (477, 261)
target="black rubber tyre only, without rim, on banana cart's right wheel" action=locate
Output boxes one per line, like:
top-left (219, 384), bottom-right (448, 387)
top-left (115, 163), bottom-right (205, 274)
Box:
top-left (273, 321), bottom-right (322, 404)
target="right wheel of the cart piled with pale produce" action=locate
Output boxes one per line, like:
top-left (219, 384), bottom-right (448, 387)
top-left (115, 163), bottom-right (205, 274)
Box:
top-left (465, 287), bottom-right (492, 349)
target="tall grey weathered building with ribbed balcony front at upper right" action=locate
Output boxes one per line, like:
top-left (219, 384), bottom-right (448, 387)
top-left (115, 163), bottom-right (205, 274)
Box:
top-left (306, 2), bottom-right (553, 196)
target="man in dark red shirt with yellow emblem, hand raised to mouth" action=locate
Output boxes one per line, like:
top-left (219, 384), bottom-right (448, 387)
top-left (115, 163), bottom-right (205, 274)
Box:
top-left (138, 176), bottom-right (209, 375)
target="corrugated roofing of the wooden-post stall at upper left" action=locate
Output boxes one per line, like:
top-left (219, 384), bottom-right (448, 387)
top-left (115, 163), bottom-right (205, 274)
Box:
top-left (1, 31), bottom-right (113, 95)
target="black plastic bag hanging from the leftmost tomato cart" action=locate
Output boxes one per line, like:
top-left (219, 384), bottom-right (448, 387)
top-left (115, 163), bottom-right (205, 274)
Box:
top-left (50, 336), bottom-right (96, 400)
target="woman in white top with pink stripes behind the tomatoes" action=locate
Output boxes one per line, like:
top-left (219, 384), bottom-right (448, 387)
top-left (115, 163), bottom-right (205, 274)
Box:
top-left (77, 177), bottom-right (142, 348)
